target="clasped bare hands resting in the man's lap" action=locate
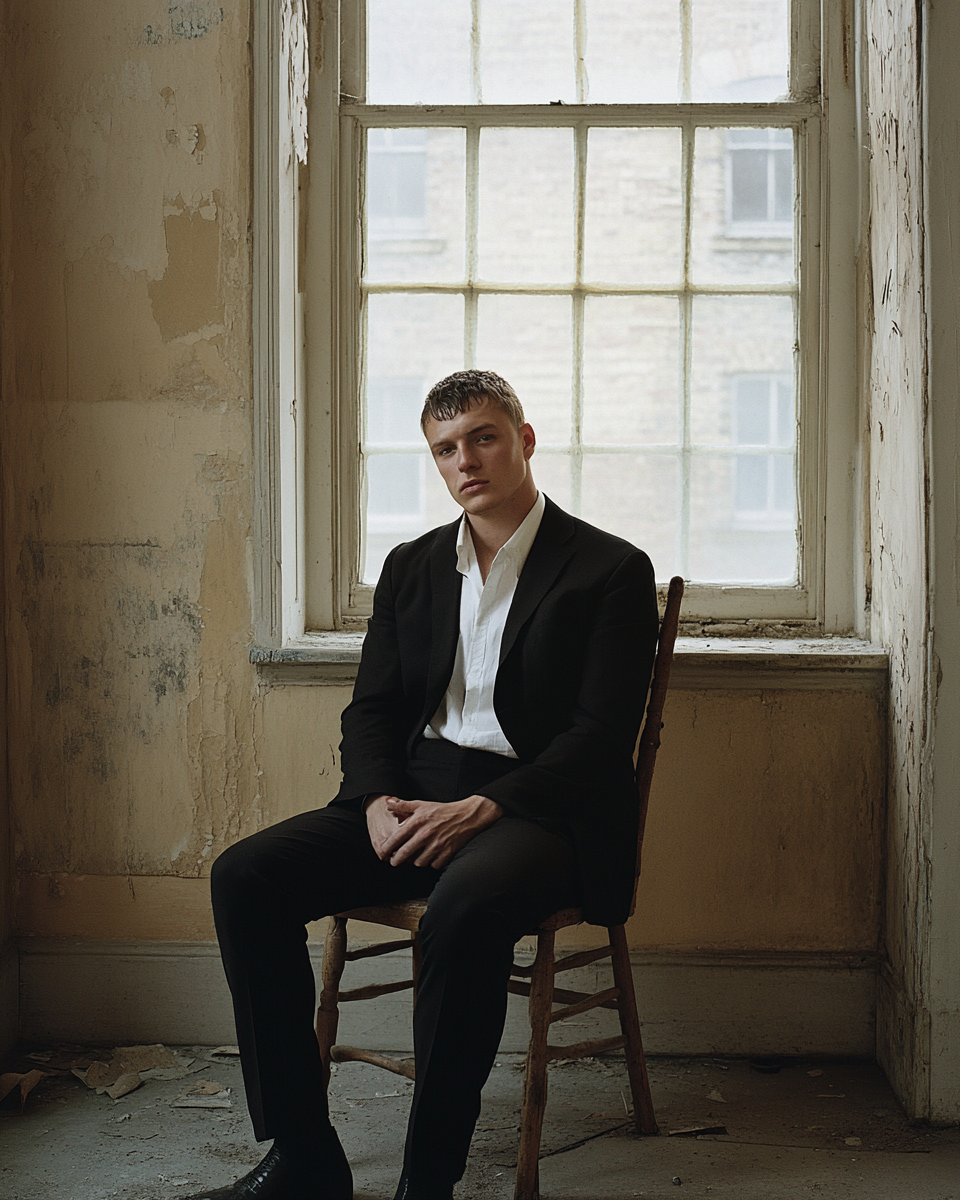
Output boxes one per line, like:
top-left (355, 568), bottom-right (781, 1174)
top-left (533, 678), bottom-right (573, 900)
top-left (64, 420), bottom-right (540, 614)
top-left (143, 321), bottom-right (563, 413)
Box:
top-left (365, 794), bottom-right (503, 871)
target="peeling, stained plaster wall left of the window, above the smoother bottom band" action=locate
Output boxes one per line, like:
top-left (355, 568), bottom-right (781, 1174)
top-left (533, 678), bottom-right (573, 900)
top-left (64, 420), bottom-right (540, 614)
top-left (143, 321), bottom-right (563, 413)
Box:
top-left (2, 0), bottom-right (258, 876)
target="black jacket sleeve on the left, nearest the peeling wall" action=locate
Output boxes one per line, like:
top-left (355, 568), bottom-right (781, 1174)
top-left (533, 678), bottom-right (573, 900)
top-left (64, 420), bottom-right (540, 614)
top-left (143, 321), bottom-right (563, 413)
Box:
top-left (332, 547), bottom-right (408, 808)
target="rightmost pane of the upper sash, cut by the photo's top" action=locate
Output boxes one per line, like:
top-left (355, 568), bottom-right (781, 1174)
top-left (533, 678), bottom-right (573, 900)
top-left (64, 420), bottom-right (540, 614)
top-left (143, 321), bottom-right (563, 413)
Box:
top-left (691, 0), bottom-right (790, 101)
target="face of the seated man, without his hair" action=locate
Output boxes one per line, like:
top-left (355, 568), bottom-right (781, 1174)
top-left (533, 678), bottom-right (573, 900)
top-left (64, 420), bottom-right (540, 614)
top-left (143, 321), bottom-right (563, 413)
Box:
top-left (424, 398), bottom-right (536, 516)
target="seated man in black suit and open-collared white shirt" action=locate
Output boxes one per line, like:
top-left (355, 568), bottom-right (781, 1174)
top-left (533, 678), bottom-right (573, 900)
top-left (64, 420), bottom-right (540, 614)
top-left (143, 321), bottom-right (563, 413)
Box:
top-left (202, 371), bottom-right (658, 1200)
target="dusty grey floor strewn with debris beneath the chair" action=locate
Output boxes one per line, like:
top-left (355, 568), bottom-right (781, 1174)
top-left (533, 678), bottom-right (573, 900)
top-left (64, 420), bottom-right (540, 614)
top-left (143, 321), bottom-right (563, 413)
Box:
top-left (0, 1046), bottom-right (960, 1200)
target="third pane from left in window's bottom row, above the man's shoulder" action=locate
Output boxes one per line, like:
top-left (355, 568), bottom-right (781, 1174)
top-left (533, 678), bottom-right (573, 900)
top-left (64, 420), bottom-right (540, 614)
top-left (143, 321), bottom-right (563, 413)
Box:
top-left (581, 454), bottom-right (679, 580)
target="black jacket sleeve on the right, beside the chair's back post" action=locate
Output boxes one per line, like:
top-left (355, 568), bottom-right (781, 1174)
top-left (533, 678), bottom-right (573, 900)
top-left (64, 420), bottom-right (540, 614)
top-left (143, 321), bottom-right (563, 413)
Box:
top-left (484, 551), bottom-right (659, 820)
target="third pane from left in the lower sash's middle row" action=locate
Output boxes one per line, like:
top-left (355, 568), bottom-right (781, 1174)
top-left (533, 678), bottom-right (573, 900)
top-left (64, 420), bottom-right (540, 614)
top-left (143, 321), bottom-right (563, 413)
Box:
top-left (583, 296), bottom-right (679, 445)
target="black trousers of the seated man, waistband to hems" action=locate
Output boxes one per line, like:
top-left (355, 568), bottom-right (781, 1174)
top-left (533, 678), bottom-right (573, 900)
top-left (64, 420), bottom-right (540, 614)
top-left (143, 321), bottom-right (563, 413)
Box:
top-left (211, 739), bottom-right (580, 1183)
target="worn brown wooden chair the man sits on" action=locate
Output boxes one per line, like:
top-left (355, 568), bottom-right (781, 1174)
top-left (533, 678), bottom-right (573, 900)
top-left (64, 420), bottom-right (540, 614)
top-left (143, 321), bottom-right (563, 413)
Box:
top-left (317, 576), bottom-right (683, 1200)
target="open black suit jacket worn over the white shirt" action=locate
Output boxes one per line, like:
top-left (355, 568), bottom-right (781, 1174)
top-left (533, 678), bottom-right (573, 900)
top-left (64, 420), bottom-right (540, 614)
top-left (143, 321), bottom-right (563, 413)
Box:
top-left (334, 499), bottom-right (658, 925)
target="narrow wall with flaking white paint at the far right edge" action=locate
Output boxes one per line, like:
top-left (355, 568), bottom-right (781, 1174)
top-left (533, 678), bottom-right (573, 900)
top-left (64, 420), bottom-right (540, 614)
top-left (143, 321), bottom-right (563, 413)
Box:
top-left (865, 0), bottom-right (960, 1123)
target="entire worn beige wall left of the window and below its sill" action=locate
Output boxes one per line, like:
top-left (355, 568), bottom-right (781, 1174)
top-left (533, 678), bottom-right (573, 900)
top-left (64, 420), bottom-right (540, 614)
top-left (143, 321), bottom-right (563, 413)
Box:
top-left (2, 0), bottom-right (884, 1032)
